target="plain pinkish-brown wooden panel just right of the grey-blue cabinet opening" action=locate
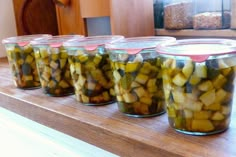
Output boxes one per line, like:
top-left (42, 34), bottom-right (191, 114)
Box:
top-left (110, 0), bottom-right (155, 37)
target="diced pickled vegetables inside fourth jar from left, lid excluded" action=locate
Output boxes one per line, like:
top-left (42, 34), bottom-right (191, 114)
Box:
top-left (111, 54), bottom-right (165, 117)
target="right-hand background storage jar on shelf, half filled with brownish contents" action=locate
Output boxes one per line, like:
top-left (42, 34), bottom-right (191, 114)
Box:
top-left (193, 0), bottom-right (231, 29)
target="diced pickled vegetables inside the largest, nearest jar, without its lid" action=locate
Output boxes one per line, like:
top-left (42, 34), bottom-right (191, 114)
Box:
top-left (162, 58), bottom-right (236, 135)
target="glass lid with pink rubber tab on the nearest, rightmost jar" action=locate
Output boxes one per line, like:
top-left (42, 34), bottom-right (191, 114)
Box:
top-left (156, 38), bottom-right (236, 62)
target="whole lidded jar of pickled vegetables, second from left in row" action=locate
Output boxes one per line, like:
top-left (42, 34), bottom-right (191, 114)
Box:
top-left (31, 35), bottom-right (83, 96)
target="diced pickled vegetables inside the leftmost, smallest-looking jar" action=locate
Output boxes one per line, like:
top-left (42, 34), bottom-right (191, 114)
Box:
top-left (6, 44), bottom-right (41, 89)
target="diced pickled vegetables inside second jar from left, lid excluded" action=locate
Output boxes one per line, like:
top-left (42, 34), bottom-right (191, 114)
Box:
top-left (35, 47), bottom-right (74, 96)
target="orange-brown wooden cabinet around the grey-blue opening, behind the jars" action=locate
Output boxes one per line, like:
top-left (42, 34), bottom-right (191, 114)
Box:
top-left (56, 0), bottom-right (155, 37)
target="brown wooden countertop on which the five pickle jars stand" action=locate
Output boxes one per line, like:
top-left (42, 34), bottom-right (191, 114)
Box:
top-left (0, 59), bottom-right (236, 157)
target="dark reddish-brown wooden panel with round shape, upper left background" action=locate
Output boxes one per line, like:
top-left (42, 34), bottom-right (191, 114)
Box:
top-left (13, 0), bottom-right (58, 35)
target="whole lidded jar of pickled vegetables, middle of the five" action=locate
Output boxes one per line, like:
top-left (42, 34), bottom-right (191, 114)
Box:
top-left (64, 36), bottom-right (124, 105)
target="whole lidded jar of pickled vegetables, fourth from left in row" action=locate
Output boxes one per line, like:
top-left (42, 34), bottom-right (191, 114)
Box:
top-left (106, 37), bottom-right (175, 117)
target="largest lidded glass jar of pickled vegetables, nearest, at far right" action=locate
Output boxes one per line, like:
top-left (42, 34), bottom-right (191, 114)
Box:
top-left (156, 39), bottom-right (236, 135)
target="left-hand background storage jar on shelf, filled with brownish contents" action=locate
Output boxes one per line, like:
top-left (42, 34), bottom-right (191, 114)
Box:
top-left (164, 0), bottom-right (194, 29)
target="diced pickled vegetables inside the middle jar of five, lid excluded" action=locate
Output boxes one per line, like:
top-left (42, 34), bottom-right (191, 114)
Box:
top-left (69, 50), bottom-right (115, 105)
